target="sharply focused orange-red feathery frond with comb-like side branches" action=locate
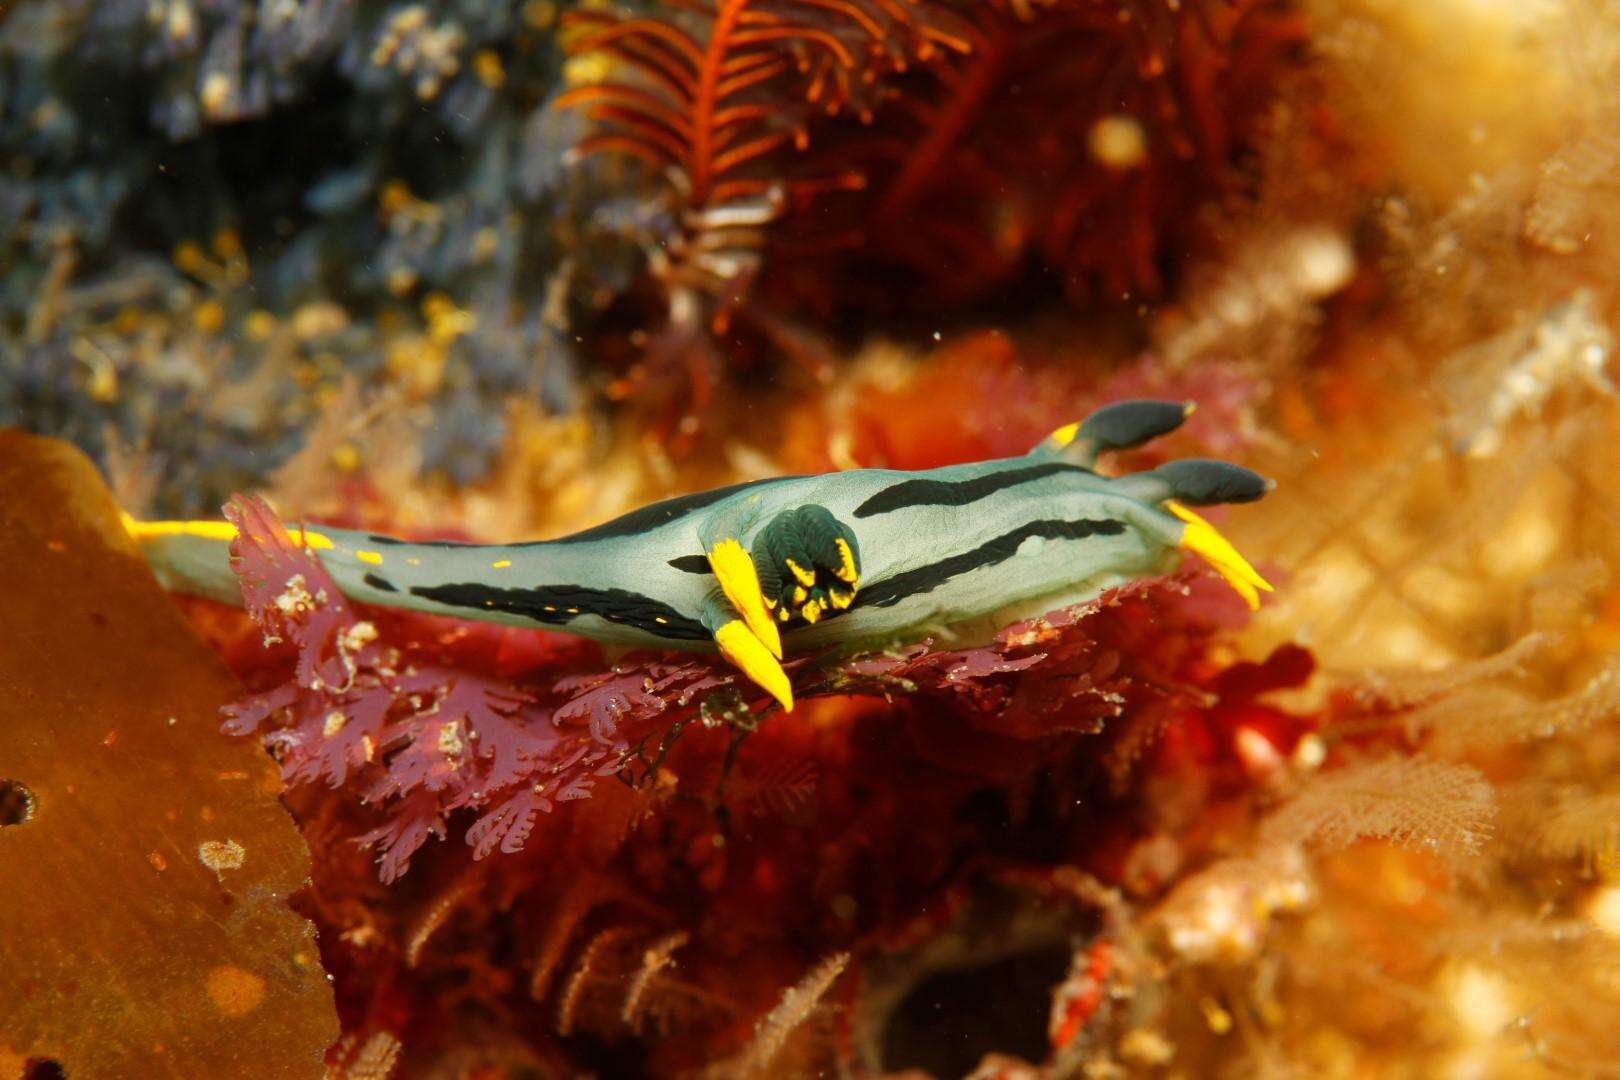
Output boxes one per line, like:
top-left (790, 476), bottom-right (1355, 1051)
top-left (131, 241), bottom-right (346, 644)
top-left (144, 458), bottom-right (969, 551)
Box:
top-left (557, 0), bottom-right (967, 440)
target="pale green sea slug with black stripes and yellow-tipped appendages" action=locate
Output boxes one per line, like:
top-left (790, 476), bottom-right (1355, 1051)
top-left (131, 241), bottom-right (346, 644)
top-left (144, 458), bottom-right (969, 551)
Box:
top-left (128, 400), bottom-right (1272, 711)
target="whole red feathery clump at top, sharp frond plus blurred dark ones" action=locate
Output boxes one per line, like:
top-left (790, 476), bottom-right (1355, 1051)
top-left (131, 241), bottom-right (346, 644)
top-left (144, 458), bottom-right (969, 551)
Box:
top-left (559, 0), bottom-right (1304, 436)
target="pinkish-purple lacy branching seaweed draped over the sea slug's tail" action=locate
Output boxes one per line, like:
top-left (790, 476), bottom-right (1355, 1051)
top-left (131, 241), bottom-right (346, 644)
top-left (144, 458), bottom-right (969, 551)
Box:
top-left (225, 499), bottom-right (729, 881)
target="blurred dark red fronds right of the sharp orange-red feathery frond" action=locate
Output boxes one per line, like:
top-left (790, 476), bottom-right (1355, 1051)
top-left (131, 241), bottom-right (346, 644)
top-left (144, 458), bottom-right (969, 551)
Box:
top-left (770, 0), bottom-right (1306, 311)
